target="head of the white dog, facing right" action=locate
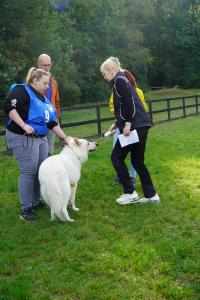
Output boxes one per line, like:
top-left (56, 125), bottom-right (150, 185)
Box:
top-left (63, 137), bottom-right (98, 163)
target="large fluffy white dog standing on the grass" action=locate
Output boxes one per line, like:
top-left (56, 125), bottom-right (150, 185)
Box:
top-left (39, 137), bottom-right (97, 222)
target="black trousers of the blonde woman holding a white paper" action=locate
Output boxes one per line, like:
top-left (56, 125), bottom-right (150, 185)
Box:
top-left (111, 127), bottom-right (156, 198)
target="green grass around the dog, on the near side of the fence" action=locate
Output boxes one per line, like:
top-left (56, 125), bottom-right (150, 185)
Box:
top-left (0, 116), bottom-right (200, 300)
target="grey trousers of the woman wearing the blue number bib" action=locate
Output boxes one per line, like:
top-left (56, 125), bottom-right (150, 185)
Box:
top-left (6, 130), bottom-right (48, 209)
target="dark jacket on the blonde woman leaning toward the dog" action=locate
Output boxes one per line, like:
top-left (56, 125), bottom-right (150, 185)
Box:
top-left (113, 72), bottom-right (151, 132)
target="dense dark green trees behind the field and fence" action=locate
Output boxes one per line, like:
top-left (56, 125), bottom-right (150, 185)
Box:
top-left (0, 0), bottom-right (200, 106)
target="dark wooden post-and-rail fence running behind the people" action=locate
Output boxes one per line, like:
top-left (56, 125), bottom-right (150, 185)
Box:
top-left (0, 95), bottom-right (200, 137)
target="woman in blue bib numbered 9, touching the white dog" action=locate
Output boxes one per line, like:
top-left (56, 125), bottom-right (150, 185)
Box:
top-left (4, 67), bottom-right (67, 221)
